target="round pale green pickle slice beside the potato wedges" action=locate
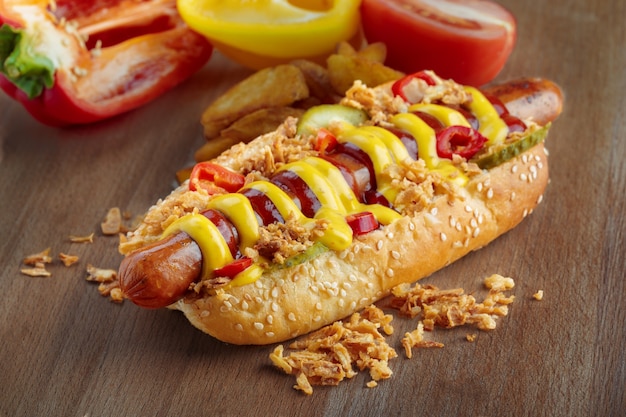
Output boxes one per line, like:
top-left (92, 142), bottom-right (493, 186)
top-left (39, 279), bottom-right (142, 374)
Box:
top-left (296, 104), bottom-right (369, 135)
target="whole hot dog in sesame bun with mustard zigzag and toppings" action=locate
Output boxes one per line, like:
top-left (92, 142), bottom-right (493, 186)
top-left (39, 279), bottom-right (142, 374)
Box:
top-left (119, 72), bottom-right (562, 344)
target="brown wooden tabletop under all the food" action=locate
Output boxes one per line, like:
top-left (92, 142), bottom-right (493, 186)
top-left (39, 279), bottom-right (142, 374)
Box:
top-left (0, 0), bottom-right (626, 417)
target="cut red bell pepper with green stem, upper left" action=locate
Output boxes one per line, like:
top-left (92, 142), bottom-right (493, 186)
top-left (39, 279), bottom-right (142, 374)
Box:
top-left (0, 0), bottom-right (213, 126)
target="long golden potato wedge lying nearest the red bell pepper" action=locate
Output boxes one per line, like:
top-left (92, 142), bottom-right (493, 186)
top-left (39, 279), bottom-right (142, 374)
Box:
top-left (201, 65), bottom-right (309, 139)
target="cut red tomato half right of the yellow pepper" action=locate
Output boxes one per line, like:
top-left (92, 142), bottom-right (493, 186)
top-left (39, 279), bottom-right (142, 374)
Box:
top-left (361, 0), bottom-right (517, 87)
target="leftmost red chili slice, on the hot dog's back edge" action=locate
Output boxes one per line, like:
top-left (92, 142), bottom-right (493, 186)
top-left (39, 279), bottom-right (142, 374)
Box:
top-left (189, 162), bottom-right (245, 194)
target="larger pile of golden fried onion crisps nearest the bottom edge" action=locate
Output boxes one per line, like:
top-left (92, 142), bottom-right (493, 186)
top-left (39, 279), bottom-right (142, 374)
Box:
top-left (270, 306), bottom-right (397, 395)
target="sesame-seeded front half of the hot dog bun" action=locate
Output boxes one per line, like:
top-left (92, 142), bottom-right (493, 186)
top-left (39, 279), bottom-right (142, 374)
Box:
top-left (172, 144), bottom-right (548, 344)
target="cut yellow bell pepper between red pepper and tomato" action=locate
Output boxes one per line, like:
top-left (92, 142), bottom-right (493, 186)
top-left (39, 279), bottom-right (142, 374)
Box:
top-left (177, 0), bottom-right (361, 69)
